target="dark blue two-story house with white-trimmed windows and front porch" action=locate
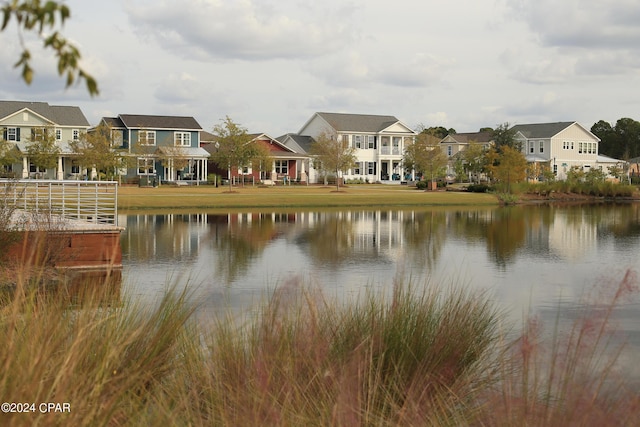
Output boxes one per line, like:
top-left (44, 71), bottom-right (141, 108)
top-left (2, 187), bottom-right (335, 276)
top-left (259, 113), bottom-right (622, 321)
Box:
top-left (101, 114), bottom-right (209, 183)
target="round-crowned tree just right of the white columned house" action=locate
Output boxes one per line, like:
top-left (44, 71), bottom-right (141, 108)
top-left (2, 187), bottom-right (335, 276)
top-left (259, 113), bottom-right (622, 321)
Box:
top-left (403, 134), bottom-right (449, 185)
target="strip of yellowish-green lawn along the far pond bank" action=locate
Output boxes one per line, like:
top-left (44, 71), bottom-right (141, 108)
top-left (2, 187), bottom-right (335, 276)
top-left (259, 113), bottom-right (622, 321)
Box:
top-left (118, 185), bottom-right (498, 212)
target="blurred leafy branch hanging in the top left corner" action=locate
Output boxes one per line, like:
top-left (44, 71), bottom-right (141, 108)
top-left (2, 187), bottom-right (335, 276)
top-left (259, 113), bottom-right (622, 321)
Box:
top-left (0, 0), bottom-right (99, 96)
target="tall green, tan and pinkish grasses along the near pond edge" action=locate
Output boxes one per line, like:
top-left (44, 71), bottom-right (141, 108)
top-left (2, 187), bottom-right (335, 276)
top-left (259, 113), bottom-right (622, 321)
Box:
top-left (0, 272), bottom-right (640, 426)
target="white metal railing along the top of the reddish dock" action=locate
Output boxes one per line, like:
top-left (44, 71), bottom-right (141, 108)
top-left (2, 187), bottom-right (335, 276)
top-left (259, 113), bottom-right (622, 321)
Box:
top-left (0, 179), bottom-right (118, 226)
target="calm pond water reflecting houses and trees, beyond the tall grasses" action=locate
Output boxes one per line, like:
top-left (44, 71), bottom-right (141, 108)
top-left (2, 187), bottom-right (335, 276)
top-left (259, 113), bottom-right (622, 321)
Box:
top-left (119, 203), bottom-right (640, 378)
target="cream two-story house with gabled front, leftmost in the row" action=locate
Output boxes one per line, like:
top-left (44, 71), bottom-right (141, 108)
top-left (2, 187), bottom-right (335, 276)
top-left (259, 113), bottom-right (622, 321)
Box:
top-left (0, 101), bottom-right (89, 180)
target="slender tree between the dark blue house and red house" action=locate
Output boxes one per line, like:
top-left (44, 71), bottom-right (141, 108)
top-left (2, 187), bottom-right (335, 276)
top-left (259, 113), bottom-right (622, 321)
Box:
top-left (211, 116), bottom-right (255, 189)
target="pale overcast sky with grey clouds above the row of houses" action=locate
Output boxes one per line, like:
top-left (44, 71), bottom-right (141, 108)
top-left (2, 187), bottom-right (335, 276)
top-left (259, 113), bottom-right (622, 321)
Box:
top-left (0, 0), bottom-right (640, 138)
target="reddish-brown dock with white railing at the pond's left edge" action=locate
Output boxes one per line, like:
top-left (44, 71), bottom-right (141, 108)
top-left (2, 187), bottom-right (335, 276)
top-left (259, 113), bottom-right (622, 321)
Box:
top-left (0, 180), bottom-right (123, 271)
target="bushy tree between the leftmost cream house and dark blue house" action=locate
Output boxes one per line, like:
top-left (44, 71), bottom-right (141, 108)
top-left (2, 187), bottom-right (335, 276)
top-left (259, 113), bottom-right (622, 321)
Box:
top-left (69, 123), bottom-right (126, 180)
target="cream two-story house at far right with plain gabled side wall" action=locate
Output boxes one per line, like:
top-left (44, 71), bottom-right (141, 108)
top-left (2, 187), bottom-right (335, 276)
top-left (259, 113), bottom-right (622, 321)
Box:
top-left (511, 122), bottom-right (623, 179)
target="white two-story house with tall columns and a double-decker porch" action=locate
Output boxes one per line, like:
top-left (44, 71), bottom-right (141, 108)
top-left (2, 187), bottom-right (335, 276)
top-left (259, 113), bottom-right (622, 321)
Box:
top-left (298, 113), bottom-right (416, 183)
